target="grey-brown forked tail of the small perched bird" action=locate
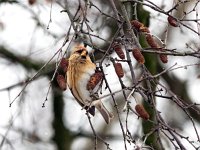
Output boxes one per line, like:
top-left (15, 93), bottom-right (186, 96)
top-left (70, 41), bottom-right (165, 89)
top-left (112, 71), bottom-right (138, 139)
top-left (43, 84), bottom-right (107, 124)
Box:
top-left (95, 101), bottom-right (114, 124)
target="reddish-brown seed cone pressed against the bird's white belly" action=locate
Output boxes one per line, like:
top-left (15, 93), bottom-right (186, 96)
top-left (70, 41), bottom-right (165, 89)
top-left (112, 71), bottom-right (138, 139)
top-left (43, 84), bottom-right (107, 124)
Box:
top-left (87, 71), bottom-right (103, 90)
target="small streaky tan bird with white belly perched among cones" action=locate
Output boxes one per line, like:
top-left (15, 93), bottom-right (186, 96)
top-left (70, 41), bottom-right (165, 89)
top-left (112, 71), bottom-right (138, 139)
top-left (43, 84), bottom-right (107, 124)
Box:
top-left (67, 45), bottom-right (113, 124)
